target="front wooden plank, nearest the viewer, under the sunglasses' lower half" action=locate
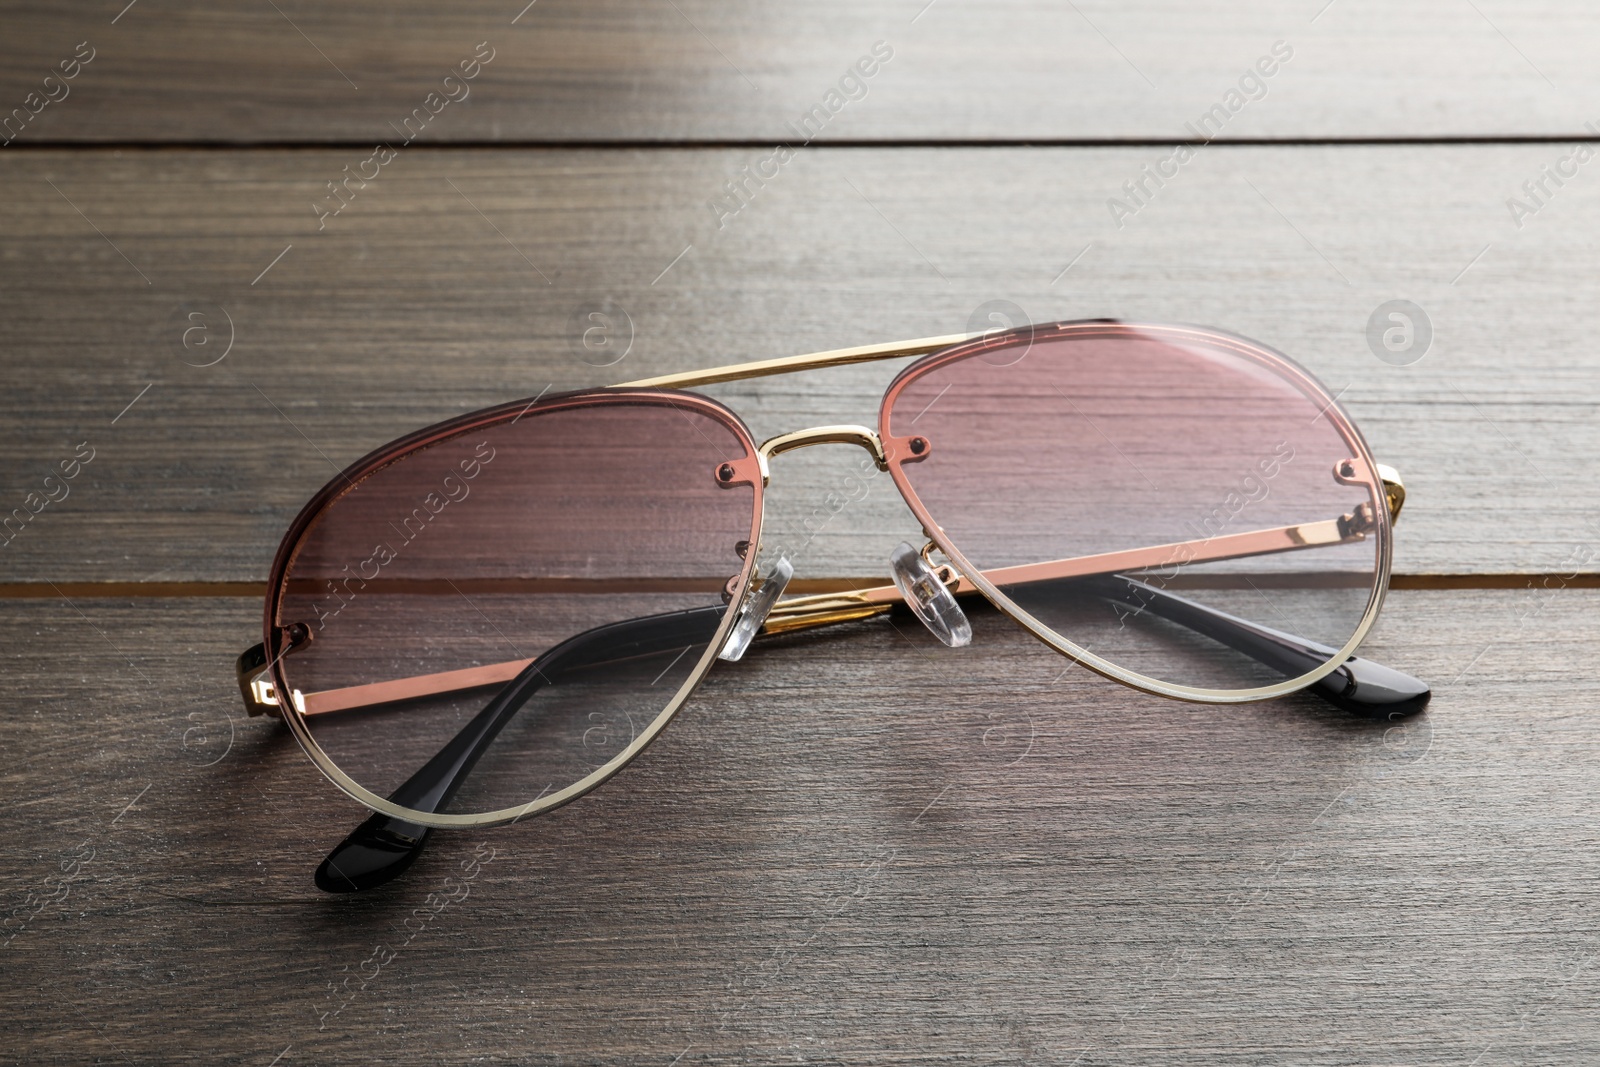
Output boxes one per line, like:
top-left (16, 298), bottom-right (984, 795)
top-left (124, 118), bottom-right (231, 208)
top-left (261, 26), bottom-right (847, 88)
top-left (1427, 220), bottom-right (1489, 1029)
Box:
top-left (0, 590), bottom-right (1600, 1064)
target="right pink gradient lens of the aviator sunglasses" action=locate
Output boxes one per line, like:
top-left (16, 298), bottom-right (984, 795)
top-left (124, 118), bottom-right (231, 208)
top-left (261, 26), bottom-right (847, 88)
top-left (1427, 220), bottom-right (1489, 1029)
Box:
top-left (882, 325), bottom-right (1389, 691)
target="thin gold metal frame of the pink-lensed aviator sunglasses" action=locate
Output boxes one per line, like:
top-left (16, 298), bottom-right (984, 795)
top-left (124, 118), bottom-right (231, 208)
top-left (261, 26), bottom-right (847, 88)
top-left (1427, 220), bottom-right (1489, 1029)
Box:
top-left (252, 322), bottom-right (1405, 827)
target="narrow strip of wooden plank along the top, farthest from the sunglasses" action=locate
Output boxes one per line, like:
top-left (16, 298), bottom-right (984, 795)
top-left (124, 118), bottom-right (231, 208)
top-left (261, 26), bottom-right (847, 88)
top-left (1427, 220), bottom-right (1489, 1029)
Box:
top-left (0, 0), bottom-right (1600, 144)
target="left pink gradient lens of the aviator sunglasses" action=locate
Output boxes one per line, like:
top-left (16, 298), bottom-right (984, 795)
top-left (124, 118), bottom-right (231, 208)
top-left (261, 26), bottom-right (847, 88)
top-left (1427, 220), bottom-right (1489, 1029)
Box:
top-left (275, 397), bottom-right (757, 814)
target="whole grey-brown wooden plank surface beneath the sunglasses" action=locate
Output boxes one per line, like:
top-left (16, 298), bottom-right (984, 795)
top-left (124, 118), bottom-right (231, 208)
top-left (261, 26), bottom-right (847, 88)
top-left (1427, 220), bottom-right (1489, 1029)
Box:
top-left (0, 0), bottom-right (1600, 1067)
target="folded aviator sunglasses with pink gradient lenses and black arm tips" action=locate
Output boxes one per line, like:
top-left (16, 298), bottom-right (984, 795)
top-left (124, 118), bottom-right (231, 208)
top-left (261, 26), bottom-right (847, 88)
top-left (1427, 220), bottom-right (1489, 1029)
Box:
top-left (238, 320), bottom-right (1430, 893)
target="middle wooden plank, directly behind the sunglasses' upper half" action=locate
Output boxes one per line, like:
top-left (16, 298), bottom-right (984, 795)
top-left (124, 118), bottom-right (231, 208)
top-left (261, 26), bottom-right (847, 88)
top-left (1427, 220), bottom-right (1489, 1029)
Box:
top-left (0, 146), bottom-right (1600, 582)
